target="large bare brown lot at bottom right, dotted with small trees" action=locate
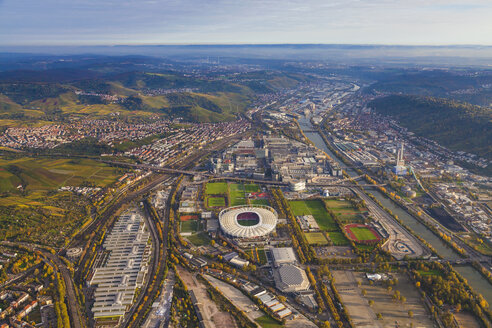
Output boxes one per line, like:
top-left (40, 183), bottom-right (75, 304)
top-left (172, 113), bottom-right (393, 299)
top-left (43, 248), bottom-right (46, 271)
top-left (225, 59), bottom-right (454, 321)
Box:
top-left (333, 271), bottom-right (434, 328)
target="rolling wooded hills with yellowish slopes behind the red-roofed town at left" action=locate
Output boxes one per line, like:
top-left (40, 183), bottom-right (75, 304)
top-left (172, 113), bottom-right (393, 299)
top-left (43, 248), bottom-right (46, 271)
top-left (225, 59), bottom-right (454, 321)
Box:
top-left (0, 68), bottom-right (309, 125)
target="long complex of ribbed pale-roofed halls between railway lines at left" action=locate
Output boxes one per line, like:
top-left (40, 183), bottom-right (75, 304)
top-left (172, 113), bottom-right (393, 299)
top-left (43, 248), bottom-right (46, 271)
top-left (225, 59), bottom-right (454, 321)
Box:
top-left (89, 211), bottom-right (152, 321)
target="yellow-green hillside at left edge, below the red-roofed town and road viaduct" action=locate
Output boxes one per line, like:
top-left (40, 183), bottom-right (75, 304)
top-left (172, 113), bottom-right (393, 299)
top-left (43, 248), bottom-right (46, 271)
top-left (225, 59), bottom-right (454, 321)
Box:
top-left (0, 157), bottom-right (124, 245)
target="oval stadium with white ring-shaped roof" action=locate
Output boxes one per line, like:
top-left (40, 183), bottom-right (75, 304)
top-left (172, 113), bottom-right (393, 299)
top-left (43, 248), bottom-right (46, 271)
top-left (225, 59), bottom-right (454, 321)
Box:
top-left (219, 205), bottom-right (278, 238)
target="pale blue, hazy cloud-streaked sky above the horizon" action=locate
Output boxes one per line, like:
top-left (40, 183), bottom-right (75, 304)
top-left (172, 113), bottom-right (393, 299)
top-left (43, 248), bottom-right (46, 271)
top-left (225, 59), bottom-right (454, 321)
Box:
top-left (0, 0), bottom-right (492, 46)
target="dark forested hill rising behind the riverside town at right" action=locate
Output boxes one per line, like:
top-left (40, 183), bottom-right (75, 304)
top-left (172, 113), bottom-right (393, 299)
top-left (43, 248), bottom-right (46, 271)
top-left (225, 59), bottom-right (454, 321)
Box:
top-left (369, 95), bottom-right (492, 159)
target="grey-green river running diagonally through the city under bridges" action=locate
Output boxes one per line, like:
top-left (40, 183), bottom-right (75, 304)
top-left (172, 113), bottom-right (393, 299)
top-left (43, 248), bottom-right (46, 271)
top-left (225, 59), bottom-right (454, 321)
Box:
top-left (298, 116), bottom-right (492, 304)
